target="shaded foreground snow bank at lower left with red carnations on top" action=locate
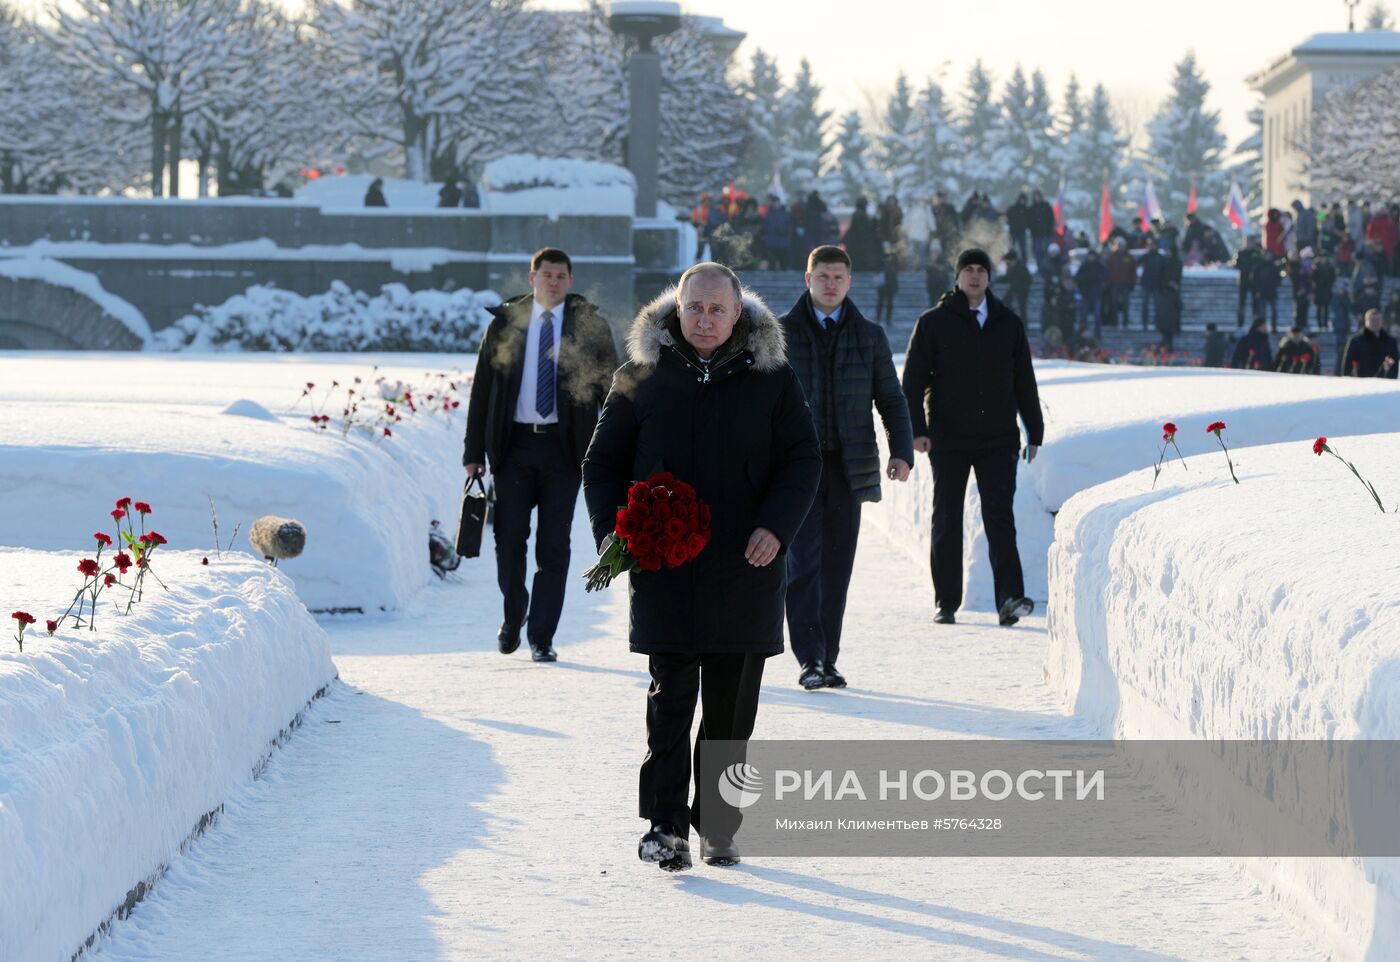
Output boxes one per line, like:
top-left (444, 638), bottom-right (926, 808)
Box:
top-left (0, 548), bottom-right (335, 962)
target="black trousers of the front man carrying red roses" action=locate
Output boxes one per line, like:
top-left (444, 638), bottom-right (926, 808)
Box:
top-left (638, 653), bottom-right (766, 837)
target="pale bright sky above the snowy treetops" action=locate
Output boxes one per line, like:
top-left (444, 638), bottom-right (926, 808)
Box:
top-left (21, 0), bottom-right (1377, 148)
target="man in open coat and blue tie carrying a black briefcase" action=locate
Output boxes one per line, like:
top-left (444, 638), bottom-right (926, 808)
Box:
top-left (462, 248), bottom-right (617, 661)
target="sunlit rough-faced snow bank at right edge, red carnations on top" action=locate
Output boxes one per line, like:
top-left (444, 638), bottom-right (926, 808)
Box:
top-left (1046, 436), bottom-right (1400, 961)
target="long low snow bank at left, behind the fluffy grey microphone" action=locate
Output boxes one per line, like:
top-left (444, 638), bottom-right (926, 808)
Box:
top-left (0, 353), bottom-right (475, 611)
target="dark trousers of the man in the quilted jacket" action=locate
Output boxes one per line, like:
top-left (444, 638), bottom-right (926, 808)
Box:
top-left (787, 451), bottom-right (861, 667)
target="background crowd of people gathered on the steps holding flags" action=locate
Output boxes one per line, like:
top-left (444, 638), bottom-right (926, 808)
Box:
top-left (692, 183), bottom-right (1400, 377)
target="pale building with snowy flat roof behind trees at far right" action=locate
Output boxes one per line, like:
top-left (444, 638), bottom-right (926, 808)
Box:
top-left (1249, 31), bottom-right (1400, 207)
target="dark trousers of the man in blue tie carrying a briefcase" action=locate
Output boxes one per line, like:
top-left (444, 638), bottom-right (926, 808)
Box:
top-left (496, 424), bottom-right (582, 646)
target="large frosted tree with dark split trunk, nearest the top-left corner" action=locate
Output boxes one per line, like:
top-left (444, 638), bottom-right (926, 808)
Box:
top-left (49, 0), bottom-right (251, 196)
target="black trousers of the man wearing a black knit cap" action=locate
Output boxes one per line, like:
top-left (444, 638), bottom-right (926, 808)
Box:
top-left (928, 448), bottom-right (1026, 611)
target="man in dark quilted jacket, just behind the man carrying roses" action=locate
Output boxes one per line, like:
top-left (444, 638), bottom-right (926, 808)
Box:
top-left (783, 246), bottom-right (914, 690)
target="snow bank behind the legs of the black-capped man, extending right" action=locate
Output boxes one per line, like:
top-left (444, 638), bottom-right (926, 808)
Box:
top-left (867, 358), bottom-right (1400, 609)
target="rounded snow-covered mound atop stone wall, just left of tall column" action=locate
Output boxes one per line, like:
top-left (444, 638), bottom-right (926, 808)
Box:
top-left (482, 154), bottom-right (637, 217)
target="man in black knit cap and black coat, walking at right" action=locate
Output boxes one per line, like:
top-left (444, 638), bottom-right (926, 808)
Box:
top-left (904, 249), bottom-right (1044, 625)
